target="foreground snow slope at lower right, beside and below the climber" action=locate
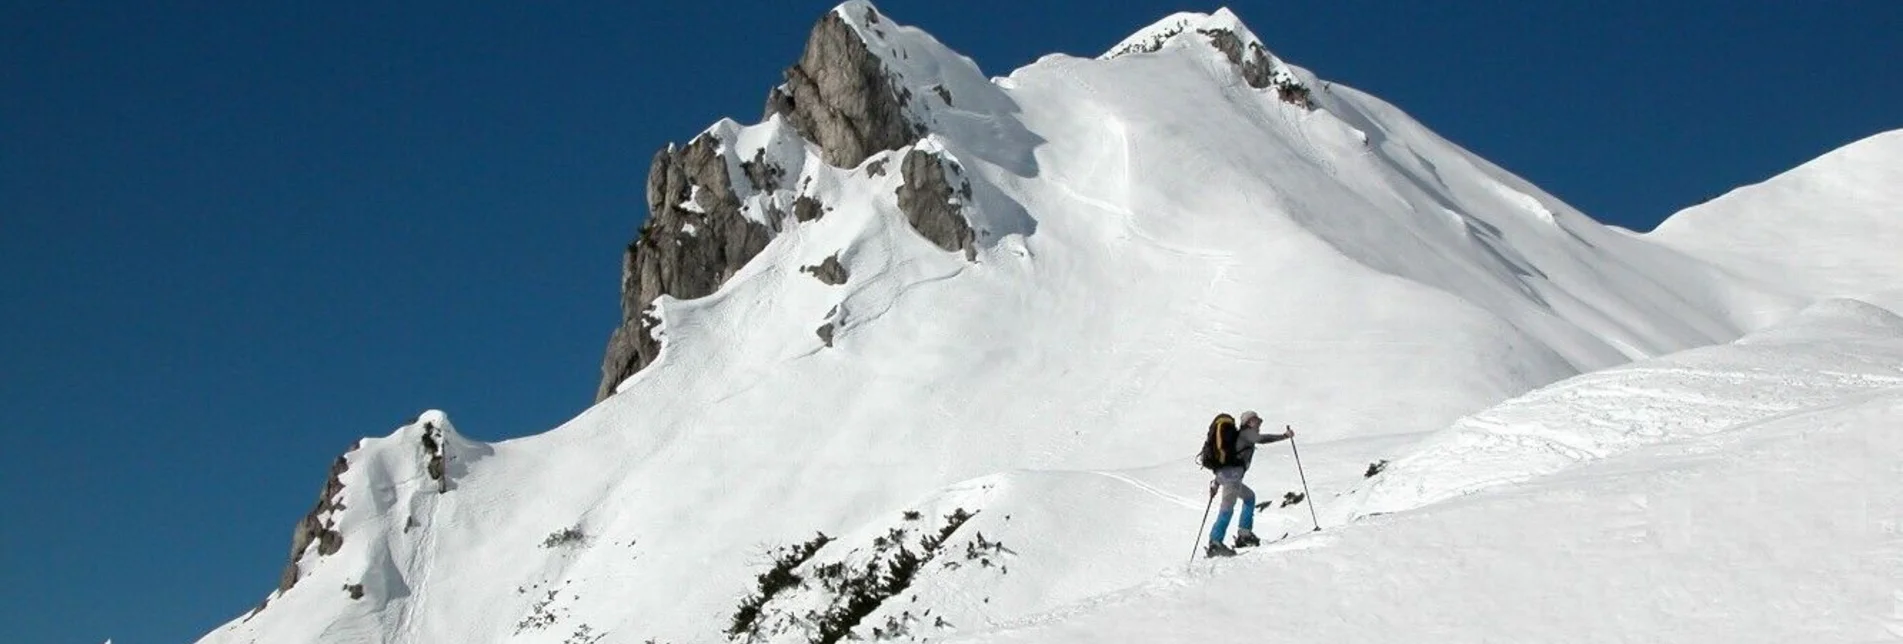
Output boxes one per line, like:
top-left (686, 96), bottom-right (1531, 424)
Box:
top-left (953, 301), bottom-right (1903, 642)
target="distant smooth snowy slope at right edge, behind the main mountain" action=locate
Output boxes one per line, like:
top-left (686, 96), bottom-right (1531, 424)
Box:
top-left (1646, 130), bottom-right (1903, 308)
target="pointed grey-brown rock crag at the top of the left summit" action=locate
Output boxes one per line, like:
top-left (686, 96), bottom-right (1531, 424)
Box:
top-left (767, 8), bottom-right (923, 168)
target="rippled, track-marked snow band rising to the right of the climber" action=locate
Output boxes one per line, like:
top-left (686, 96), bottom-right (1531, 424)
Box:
top-left (1351, 299), bottom-right (1903, 513)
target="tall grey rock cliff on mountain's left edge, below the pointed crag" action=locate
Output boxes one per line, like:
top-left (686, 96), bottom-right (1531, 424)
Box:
top-left (596, 135), bottom-right (776, 400)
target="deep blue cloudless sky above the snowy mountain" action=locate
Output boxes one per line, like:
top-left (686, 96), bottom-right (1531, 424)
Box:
top-left (0, 0), bottom-right (1903, 644)
